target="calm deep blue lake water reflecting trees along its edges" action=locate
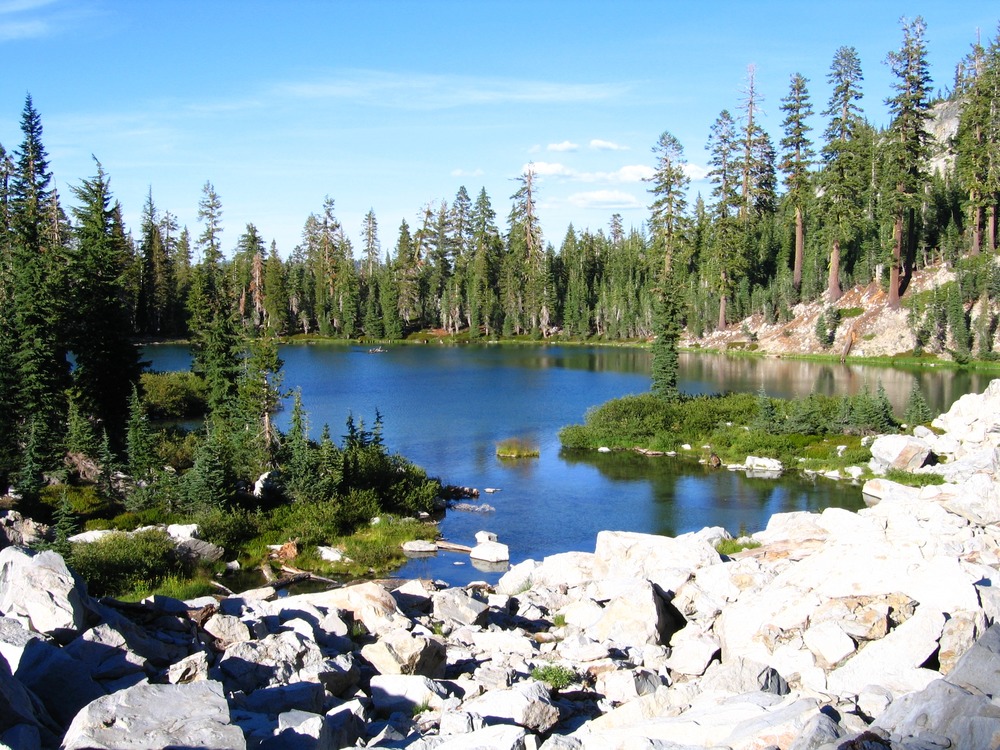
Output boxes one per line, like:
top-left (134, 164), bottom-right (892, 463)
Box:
top-left (145, 344), bottom-right (991, 584)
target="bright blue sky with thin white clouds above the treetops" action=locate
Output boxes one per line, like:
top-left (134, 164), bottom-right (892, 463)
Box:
top-left (0, 0), bottom-right (1000, 257)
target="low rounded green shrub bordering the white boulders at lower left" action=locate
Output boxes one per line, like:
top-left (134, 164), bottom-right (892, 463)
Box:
top-left (71, 531), bottom-right (187, 596)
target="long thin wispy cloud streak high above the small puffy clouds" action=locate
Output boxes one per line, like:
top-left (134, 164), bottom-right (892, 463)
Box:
top-left (275, 70), bottom-right (629, 110)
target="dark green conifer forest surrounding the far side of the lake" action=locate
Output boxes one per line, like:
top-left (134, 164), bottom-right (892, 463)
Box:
top-left (0, 13), bottom-right (1000, 552)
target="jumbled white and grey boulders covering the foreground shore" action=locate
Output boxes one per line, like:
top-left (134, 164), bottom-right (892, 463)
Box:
top-left (0, 380), bottom-right (1000, 750)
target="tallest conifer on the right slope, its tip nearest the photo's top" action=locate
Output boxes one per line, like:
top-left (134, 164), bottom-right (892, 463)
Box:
top-left (885, 16), bottom-right (931, 308)
